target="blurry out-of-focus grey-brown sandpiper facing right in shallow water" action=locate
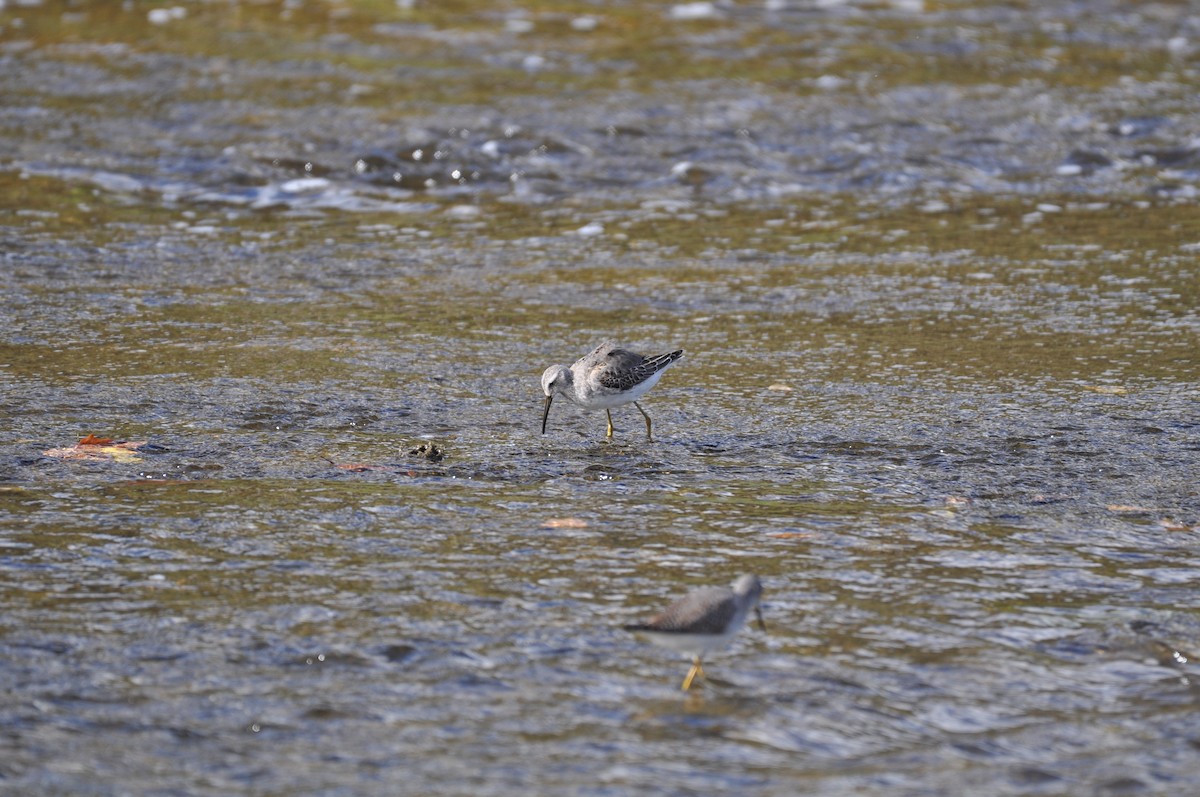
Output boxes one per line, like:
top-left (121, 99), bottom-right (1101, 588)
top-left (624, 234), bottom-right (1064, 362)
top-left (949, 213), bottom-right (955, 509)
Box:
top-left (624, 575), bottom-right (767, 691)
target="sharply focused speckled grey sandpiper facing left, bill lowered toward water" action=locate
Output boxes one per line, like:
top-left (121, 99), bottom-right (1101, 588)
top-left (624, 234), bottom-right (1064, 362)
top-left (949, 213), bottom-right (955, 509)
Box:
top-left (541, 341), bottom-right (683, 439)
